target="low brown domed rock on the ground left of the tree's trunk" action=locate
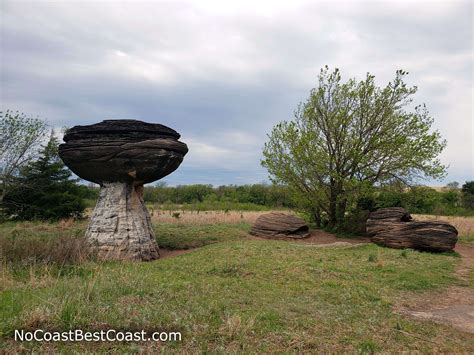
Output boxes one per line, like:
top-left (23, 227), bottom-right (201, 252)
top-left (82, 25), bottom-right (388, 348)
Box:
top-left (250, 212), bottom-right (309, 239)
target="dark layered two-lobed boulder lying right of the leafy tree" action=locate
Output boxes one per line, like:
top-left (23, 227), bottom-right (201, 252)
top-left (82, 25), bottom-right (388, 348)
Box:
top-left (367, 207), bottom-right (458, 252)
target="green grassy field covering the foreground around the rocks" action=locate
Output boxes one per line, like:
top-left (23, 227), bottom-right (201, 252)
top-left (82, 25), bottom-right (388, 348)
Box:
top-left (0, 212), bottom-right (474, 352)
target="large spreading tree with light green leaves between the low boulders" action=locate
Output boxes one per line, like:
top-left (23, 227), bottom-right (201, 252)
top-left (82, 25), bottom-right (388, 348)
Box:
top-left (262, 66), bottom-right (446, 227)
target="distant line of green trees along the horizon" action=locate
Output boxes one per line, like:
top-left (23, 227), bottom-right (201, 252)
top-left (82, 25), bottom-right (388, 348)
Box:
top-left (83, 182), bottom-right (474, 216)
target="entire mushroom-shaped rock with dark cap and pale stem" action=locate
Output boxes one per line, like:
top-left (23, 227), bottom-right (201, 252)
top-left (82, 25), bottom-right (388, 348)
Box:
top-left (59, 120), bottom-right (188, 260)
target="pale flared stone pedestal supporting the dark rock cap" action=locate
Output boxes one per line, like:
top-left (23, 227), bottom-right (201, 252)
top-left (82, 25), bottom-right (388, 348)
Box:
top-left (86, 182), bottom-right (160, 261)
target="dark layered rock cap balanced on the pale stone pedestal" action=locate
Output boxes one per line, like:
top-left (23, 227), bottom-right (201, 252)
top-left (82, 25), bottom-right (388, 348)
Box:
top-left (59, 120), bottom-right (188, 184)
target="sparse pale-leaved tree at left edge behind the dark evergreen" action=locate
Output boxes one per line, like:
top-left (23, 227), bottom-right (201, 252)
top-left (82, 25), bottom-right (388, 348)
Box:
top-left (0, 110), bottom-right (47, 203)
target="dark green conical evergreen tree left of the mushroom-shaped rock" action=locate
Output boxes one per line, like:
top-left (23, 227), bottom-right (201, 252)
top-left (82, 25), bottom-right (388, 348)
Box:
top-left (3, 132), bottom-right (85, 220)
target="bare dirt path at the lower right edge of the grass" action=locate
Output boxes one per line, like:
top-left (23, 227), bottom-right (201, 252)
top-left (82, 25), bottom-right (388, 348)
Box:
top-left (395, 245), bottom-right (474, 334)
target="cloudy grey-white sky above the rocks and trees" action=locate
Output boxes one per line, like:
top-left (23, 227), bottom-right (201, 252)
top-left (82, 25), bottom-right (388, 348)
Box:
top-left (0, 0), bottom-right (474, 185)
